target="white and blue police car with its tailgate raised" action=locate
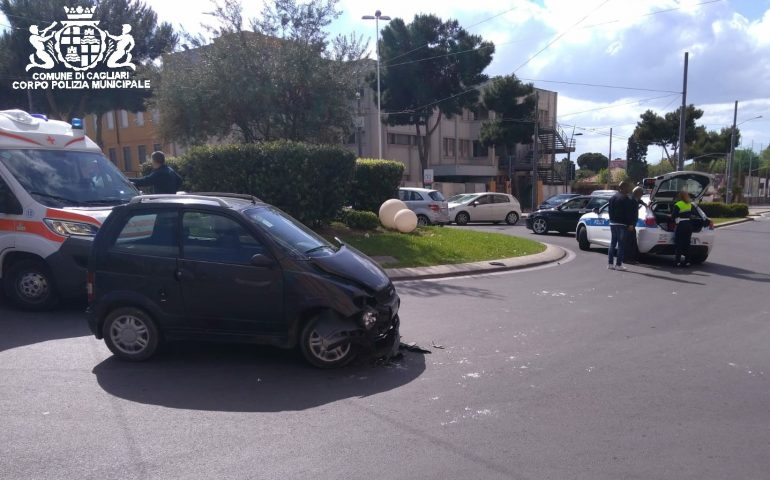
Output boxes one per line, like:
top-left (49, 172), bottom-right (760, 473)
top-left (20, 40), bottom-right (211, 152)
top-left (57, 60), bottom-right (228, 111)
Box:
top-left (577, 172), bottom-right (714, 263)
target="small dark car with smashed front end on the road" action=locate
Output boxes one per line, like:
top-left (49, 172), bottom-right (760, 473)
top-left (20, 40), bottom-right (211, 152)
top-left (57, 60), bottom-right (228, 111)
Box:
top-left (88, 194), bottom-right (400, 368)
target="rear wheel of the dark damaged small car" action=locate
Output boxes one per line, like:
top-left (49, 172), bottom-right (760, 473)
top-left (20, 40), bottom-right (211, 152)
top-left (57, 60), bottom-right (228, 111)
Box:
top-left (102, 307), bottom-right (160, 362)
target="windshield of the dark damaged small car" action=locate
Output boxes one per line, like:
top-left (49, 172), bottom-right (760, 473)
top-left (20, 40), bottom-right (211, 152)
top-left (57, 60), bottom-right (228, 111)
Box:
top-left (245, 206), bottom-right (337, 256)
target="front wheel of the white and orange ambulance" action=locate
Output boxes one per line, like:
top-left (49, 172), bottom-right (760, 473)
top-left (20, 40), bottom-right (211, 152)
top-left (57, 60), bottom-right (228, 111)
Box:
top-left (3, 260), bottom-right (59, 311)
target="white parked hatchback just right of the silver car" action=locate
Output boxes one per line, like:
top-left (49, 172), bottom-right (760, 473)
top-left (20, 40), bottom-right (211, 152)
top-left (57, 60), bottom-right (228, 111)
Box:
top-left (449, 193), bottom-right (521, 225)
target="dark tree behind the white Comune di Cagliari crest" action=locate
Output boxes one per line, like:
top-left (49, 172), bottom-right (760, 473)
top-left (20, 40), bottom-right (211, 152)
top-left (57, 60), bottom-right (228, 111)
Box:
top-left (0, 0), bottom-right (177, 144)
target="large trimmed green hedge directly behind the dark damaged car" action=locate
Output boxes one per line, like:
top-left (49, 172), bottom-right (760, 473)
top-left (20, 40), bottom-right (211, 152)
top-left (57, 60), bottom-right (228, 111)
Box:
top-left (144, 141), bottom-right (356, 224)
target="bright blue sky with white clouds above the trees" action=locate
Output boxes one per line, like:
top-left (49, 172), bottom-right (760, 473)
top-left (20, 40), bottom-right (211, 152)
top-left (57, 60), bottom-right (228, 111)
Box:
top-left (6, 0), bottom-right (770, 162)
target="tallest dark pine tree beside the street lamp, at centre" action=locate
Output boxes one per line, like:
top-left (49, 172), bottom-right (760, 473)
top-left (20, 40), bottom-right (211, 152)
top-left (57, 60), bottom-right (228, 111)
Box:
top-left (370, 15), bottom-right (494, 173)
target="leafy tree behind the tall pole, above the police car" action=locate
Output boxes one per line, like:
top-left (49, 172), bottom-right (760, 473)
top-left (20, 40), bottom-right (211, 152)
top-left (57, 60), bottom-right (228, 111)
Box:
top-left (633, 105), bottom-right (703, 167)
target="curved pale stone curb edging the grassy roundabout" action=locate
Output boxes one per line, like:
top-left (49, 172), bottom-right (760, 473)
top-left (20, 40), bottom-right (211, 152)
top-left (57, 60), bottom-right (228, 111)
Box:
top-left (385, 242), bottom-right (567, 280)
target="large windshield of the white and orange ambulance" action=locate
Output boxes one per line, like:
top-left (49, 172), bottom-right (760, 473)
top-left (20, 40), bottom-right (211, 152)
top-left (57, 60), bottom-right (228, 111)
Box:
top-left (0, 149), bottom-right (139, 207)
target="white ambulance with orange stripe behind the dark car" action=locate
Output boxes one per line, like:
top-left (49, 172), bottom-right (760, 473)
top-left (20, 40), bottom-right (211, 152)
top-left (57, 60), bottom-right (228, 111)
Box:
top-left (0, 110), bottom-right (139, 310)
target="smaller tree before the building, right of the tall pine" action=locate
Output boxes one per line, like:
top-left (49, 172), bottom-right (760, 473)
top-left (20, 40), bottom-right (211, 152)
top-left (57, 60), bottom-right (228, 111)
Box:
top-left (480, 74), bottom-right (535, 162)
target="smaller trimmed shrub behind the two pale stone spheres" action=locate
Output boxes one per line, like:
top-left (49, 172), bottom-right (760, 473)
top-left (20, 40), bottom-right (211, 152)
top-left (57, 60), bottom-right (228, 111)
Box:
top-left (350, 159), bottom-right (404, 212)
